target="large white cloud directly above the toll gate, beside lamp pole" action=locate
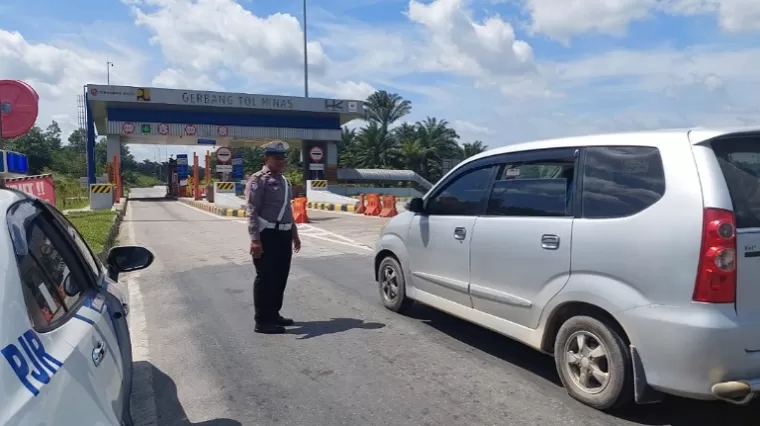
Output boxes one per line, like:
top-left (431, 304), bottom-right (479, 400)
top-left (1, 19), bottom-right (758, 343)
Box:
top-left (130, 0), bottom-right (329, 87)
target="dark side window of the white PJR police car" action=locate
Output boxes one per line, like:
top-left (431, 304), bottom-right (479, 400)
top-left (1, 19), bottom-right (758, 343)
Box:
top-left (8, 202), bottom-right (87, 331)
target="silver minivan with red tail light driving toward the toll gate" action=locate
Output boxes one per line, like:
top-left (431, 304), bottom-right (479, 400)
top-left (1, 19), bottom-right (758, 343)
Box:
top-left (375, 128), bottom-right (760, 410)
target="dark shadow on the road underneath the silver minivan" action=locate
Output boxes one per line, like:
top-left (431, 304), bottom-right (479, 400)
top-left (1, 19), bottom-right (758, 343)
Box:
top-left (406, 303), bottom-right (760, 426)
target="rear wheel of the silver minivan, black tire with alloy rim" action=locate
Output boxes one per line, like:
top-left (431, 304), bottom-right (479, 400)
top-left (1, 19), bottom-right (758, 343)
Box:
top-left (554, 316), bottom-right (633, 411)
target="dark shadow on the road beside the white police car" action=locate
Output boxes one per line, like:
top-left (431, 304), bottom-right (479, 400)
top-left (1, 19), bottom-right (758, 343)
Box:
top-left (138, 361), bottom-right (242, 426)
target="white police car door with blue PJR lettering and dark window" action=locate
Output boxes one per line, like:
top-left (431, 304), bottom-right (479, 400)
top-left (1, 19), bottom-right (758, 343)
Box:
top-left (0, 201), bottom-right (122, 426)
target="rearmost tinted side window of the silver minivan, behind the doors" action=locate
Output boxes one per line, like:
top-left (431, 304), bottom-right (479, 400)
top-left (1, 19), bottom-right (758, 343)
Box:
top-left (582, 146), bottom-right (665, 219)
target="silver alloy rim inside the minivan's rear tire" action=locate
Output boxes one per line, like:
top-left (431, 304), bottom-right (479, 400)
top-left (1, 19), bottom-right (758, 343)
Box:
top-left (564, 330), bottom-right (610, 394)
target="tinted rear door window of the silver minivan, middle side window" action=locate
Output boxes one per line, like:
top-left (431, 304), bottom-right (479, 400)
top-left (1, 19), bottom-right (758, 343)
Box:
top-left (486, 158), bottom-right (575, 216)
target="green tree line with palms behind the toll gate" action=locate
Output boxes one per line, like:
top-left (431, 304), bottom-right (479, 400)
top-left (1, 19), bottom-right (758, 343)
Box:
top-left (2, 91), bottom-right (487, 184)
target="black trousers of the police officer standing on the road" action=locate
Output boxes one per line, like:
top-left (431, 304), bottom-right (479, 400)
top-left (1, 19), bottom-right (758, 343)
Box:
top-left (253, 229), bottom-right (293, 324)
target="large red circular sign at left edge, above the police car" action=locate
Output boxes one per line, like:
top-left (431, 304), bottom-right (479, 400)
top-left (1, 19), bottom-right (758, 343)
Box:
top-left (0, 80), bottom-right (40, 138)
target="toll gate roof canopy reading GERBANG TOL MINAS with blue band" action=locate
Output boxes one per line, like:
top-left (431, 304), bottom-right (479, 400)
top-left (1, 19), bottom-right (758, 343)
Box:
top-left (84, 84), bottom-right (364, 183)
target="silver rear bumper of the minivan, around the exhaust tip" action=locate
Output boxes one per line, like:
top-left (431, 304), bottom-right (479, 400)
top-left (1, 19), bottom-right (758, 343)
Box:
top-left (616, 303), bottom-right (760, 403)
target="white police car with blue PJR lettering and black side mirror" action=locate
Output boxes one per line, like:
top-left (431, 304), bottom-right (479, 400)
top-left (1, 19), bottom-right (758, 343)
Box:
top-left (0, 188), bottom-right (153, 426)
